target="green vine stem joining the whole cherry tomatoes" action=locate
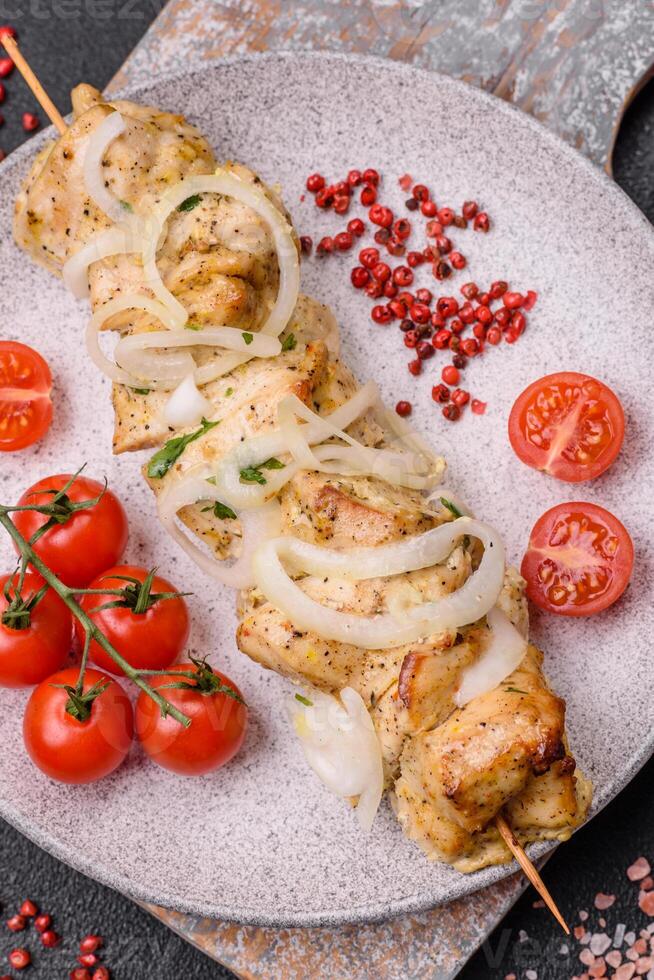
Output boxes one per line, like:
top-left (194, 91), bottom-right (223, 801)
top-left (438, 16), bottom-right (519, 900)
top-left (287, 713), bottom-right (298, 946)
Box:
top-left (0, 504), bottom-right (191, 728)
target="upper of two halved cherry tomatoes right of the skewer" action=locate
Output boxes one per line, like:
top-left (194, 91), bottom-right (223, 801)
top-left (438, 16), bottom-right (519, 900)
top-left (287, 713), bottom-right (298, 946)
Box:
top-left (509, 371), bottom-right (624, 483)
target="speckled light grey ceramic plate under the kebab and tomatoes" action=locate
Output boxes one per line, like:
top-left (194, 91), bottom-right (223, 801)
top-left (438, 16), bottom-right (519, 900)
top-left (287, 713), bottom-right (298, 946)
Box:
top-left (0, 55), bottom-right (654, 926)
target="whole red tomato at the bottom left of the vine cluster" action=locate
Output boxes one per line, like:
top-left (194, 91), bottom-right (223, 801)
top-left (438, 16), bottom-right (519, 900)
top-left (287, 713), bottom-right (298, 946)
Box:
top-left (23, 667), bottom-right (134, 783)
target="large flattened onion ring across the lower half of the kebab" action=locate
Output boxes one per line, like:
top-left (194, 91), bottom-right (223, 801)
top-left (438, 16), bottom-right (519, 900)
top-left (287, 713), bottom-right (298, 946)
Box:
top-left (253, 517), bottom-right (504, 650)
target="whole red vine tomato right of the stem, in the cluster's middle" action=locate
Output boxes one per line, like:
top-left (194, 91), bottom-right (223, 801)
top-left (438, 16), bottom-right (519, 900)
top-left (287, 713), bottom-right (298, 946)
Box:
top-left (75, 565), bottom-right (189, 676)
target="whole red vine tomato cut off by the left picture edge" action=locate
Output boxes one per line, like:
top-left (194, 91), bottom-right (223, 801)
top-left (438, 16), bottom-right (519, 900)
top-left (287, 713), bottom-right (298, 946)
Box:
top-left (0, 572), bottom-right (73, 687)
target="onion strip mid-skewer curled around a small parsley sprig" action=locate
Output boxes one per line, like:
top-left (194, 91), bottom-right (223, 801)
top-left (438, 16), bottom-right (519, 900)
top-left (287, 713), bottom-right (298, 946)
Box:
top-left (214, 381), bottom-right (379, 510)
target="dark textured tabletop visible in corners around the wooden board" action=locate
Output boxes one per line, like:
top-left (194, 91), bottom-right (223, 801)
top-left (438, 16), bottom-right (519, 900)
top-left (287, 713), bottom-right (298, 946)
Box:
top-left (0, 0), bottom-right (654, 980)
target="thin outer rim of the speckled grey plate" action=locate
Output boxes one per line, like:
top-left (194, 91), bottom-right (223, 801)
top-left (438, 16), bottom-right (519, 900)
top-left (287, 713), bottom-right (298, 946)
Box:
top-left (0, 50), bottom-right (654, 929)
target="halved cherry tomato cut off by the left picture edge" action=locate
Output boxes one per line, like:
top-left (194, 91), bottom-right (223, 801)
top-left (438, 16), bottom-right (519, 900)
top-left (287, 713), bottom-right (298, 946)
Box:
top-left (0, 340), bottom-right (52, 452)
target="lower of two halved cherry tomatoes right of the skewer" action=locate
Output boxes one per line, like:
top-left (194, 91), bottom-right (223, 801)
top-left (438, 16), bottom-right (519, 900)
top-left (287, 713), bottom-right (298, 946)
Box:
top-left (521, 502), bottom-right (634, 616)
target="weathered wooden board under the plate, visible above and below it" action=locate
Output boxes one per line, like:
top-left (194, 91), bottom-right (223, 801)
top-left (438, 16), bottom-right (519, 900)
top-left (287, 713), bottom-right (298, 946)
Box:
top-left (111, 0), bottom-right (654, 980)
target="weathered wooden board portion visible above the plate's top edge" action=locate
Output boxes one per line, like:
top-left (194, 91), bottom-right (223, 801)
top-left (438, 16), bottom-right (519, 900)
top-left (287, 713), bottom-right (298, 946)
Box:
top-left (110, 0), bottom-right (654, 171)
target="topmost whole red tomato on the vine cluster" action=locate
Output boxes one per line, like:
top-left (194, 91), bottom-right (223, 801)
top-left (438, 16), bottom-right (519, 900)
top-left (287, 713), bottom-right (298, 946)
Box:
top-left (14, 473), bottom-right (127, 589)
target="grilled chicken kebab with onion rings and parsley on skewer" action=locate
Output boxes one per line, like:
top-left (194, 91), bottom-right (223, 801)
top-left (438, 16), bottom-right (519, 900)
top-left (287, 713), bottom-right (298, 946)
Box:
top-left (14, 85), bottom-right (591, 871)
